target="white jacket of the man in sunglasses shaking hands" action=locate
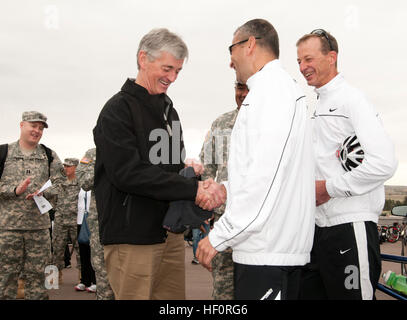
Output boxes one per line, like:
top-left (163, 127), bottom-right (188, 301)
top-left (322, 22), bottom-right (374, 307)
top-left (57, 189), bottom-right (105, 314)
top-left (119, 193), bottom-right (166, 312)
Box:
top-left (209, 60), bottom-right (315, 266)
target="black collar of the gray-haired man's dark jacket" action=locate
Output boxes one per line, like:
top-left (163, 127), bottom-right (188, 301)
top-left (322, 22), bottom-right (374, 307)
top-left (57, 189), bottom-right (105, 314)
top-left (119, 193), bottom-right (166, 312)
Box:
top-left (121, 78), bottom-right (172, 116)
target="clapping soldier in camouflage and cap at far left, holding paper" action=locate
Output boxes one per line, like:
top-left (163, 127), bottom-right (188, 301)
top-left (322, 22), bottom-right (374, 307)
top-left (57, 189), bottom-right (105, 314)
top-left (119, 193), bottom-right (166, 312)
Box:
top-left (0, 111), bottom-right (64, 300)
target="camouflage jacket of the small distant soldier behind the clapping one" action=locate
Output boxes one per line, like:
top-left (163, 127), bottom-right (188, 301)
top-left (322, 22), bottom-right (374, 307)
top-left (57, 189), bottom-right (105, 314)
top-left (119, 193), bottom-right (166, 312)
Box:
top-left (55, 178), bottom-right (81, 225)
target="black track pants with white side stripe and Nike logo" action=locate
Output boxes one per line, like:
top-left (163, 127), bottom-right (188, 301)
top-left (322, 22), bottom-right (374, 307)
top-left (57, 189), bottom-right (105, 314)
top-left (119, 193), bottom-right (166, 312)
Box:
top-left (300, 221), bottom-right (381, 300)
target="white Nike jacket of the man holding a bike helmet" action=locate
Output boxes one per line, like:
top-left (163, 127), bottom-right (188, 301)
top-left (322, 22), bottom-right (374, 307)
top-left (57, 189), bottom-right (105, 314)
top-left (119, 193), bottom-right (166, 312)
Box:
top-left (312, 74), bottom-right (397, 227)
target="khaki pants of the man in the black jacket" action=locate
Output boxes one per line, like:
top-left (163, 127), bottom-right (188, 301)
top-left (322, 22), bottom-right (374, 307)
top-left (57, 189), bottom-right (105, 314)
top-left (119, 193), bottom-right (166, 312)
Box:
top-left (104, 232), bottom-right (185, 300)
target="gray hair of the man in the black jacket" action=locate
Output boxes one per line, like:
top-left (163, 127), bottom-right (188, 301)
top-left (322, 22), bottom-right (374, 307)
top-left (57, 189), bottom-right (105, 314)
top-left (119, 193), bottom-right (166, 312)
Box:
top-left (137, 28), bottom-right (188, 69)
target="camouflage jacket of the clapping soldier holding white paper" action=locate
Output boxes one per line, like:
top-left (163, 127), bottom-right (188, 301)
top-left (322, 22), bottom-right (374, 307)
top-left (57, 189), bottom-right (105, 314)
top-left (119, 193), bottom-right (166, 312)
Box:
top-left (0, 141), bottom-right (64, 230)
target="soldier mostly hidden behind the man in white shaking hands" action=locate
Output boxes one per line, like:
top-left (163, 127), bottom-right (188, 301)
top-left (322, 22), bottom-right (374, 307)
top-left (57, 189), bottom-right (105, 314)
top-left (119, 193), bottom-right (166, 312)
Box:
top-left (200, 83), bottom-right (249, 300)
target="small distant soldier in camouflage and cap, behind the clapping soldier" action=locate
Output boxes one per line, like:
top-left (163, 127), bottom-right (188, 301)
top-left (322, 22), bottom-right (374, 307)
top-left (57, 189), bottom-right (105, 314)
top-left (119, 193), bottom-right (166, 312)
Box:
top-left (52, 158), bottom-right (81, 280)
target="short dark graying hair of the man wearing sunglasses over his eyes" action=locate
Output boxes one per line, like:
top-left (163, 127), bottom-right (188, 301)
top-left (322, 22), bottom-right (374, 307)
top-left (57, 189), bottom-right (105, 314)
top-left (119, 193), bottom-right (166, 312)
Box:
top-left (234, 19), bottom-right (280, 59)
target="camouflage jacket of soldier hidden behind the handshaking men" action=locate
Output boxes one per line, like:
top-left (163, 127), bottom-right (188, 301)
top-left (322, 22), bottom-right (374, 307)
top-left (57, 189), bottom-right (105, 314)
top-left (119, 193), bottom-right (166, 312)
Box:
top-left (199, 108), bottom-right (239, 221)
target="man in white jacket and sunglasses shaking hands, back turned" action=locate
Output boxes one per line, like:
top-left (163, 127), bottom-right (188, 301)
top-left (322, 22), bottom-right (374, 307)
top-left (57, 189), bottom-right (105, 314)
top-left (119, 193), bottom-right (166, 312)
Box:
top-left (197, 19), bottom-right (315, 299)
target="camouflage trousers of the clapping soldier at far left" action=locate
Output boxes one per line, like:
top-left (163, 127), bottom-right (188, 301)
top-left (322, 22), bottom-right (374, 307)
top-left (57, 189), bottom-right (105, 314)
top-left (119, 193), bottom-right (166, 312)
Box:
top-left (0, 229), bottom-right (51, 300)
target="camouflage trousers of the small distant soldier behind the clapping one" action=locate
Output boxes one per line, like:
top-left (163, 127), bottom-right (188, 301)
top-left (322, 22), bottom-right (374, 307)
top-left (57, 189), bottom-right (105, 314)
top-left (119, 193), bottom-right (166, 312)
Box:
top-left (52, 224), bottom-right (81, 270)
